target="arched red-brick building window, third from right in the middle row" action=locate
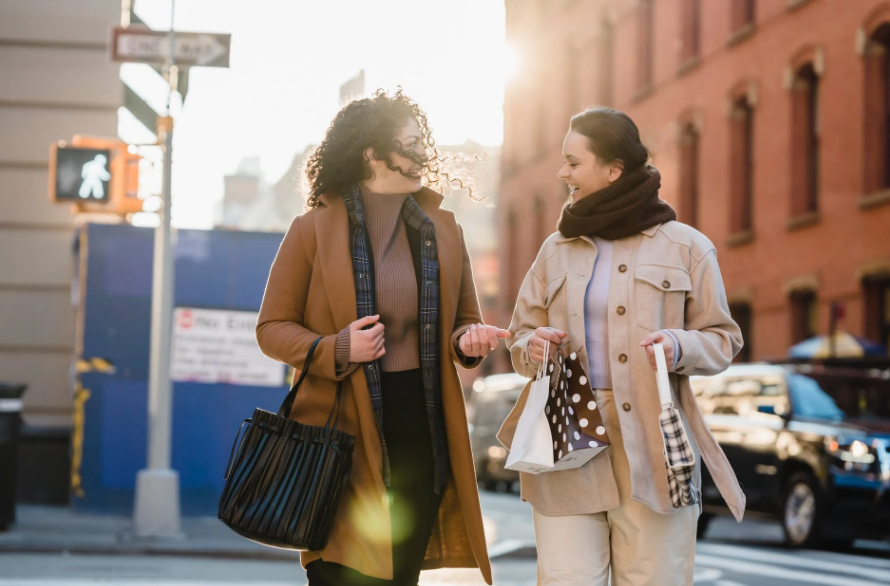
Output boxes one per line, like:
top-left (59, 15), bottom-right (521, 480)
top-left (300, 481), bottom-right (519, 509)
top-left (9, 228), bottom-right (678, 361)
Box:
top-left (729, 96), bottom-right (754, 234)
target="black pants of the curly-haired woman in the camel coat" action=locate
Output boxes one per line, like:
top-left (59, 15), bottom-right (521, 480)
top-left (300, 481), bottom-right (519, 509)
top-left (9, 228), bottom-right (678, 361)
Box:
top-left (306, 369), bottom-right (441, 586)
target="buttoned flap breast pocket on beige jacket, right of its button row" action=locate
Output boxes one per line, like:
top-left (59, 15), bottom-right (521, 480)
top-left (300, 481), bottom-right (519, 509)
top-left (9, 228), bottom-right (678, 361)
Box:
top-left (634, 265), bottom-right (692, 332)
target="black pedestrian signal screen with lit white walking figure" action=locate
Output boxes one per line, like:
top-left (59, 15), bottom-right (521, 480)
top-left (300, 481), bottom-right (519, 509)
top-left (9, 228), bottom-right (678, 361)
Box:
top-left (50, 146), bottom-right (111, 203)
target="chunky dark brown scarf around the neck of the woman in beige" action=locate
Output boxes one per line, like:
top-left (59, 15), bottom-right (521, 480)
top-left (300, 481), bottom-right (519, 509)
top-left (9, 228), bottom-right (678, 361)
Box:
top-left (556, 165), bottom-right (677, 240)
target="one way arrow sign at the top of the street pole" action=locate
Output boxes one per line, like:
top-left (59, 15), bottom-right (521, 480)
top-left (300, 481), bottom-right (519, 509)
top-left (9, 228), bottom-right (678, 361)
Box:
top-left (111, 26), bottom-right (232, 67)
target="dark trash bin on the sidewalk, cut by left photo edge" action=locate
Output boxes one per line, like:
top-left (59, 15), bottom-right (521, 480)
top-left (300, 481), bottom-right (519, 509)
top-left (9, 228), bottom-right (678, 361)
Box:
top-left (0, 382), bottom-right (28, 531)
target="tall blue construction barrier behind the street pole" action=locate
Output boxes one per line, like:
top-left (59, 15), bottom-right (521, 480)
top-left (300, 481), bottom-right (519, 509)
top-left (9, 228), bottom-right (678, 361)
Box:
top-left (74, 224), bottom-right (287, 515)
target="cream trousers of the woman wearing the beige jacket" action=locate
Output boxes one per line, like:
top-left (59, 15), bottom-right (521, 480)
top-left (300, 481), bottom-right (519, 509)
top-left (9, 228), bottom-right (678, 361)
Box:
top-left (534, 389), bottom-right (698, 586)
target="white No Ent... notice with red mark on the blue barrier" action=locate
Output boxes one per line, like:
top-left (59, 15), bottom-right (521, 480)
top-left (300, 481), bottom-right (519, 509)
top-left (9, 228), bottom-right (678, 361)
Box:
top-left (170, 307), bottom-right (285, 387)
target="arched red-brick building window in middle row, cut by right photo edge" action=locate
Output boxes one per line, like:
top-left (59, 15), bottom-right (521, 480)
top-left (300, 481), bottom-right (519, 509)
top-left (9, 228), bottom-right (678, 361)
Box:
top-left (863, 24), bottom-right (890, 193)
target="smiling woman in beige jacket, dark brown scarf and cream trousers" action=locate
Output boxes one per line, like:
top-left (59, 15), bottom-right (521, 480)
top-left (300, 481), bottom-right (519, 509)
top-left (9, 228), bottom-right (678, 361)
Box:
top-left (498, 108), bottom-right (745, 586)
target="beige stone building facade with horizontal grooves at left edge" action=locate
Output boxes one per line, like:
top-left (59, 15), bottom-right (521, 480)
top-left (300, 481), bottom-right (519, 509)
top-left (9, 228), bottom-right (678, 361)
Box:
top-left (0, 0), bottom-right (122, 428)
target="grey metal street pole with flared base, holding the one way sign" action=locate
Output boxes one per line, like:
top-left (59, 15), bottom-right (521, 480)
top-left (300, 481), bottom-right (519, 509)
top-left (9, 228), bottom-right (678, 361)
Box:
top-left (133, 0), bottom-right (181, 537)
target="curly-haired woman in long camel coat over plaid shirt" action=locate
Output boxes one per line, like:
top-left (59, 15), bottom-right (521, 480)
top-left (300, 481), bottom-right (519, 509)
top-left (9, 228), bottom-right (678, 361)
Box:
top-left (257, 91), bottom-right (509, 586)
